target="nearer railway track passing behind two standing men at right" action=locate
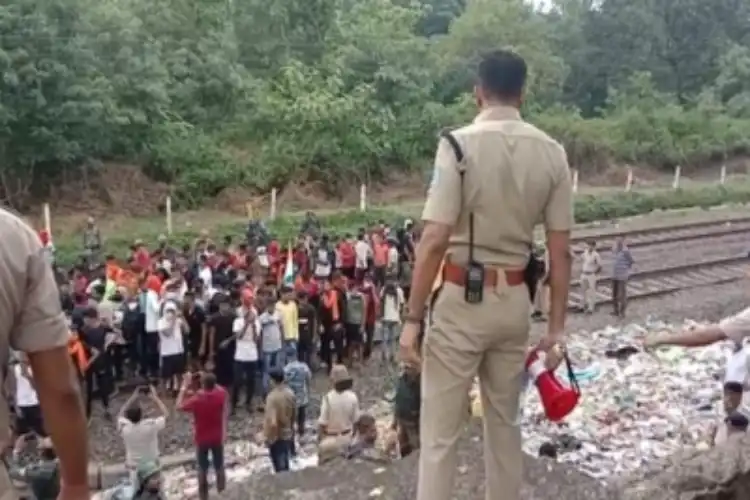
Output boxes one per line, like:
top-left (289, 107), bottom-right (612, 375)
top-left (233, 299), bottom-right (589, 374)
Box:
top-left (568, 255), bottom-right (750, 310)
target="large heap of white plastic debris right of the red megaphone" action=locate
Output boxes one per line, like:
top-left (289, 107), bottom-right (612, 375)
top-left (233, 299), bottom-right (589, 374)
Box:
top-left (522, 321), bottom-right (731, 480)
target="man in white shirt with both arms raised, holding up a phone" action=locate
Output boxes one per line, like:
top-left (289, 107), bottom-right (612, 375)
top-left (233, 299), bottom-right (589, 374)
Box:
top-left (117, 386), bottom-right (169, 479)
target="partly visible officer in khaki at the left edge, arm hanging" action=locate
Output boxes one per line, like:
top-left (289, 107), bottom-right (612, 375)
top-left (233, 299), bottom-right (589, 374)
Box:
top-left (0, 209), bottom-right (90, 500)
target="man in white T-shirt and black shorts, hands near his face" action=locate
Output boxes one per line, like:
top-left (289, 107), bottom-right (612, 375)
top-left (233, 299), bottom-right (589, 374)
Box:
top-left (159, 302), bottom-right (187, 395)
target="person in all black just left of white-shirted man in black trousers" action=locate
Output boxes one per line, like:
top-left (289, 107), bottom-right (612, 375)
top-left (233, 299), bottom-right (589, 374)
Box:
top-left (208, 294), bottom-right (236, 388)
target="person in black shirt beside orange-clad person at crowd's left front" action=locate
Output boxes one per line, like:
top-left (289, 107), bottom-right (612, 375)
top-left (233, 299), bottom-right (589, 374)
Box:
top-left (81, 307), bottom-right (114, 420)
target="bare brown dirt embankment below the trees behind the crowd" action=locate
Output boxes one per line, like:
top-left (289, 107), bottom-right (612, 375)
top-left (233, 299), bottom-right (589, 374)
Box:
top-left (26, 157), bottom-right (750, 235)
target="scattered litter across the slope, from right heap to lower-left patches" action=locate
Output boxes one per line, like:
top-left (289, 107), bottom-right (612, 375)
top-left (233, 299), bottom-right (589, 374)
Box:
top-left (95, 320), bottom-right (733, 500)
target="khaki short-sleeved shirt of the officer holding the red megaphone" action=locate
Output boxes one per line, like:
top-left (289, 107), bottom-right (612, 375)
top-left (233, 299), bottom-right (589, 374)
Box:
top-left (422, 106), bottom-right (574, 269)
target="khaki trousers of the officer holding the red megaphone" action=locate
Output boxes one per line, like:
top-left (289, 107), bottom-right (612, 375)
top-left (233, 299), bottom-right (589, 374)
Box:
top-left (417, 280), bottom-right (530, 500)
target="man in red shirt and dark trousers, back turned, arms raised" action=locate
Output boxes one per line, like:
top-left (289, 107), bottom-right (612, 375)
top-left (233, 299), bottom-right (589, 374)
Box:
top-left (177, 373), bottom-right (229, 500)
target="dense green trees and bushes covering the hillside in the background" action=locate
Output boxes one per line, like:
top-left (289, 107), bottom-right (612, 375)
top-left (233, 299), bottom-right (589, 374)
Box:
top-left (0, 0), bottom-right (750, 208)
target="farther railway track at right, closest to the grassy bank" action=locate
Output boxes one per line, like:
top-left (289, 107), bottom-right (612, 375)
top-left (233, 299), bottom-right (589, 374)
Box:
top-left (571, 217), bottom-right (750, 254)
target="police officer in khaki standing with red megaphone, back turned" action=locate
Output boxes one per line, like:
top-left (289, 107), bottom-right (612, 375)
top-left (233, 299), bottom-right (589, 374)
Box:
top-left (400, 51), bottom-right (573, 500)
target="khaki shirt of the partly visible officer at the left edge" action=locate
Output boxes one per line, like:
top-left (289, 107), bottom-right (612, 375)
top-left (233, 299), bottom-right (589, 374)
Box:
top-left (0, 209), bottom-right (69, 500)
